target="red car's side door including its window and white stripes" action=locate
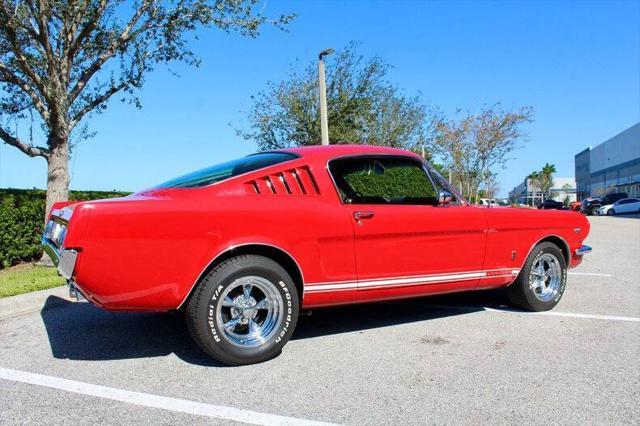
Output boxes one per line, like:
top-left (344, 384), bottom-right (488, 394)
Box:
top-left (329, 156), bottom-right (488, 294)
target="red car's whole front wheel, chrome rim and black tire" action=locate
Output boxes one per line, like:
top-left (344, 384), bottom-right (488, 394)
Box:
top-left (507, 242), bottom-right (567, 311)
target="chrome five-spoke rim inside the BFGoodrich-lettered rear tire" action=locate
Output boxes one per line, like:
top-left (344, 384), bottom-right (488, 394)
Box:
top-left (216, 276), bottom-right (284, 347)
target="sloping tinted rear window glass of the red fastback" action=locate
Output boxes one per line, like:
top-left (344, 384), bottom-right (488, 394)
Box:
top-left (156, 152), bottom-right (298, 188)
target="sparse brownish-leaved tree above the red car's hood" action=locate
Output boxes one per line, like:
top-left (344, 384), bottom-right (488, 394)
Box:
top-left (434, 104), bottom-right (533, 201)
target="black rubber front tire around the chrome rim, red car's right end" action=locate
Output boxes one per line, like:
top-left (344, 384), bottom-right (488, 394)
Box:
top-left (507, 242), bottom-right (567, 312)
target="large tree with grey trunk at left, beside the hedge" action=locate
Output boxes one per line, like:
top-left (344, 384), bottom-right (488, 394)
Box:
top-left (0, 0), bottom-right (292, 211)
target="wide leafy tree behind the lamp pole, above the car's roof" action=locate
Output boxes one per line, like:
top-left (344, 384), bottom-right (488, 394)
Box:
top-left (238, 43), bottom-right (432, 152)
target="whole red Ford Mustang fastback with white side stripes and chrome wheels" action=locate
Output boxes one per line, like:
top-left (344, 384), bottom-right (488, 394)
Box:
top-left (43, 145), bottom-right (590, 365)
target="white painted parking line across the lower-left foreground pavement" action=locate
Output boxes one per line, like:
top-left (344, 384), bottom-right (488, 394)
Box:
top-left (0, 367), bottom-right (338, 425)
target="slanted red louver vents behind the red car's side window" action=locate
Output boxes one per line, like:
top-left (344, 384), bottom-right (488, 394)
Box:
top-left (243, 166), bottom-right (320, 195)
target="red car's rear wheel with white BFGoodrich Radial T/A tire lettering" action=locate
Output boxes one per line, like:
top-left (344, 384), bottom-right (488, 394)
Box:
top-left (186, 255), bottom-right (300, 365)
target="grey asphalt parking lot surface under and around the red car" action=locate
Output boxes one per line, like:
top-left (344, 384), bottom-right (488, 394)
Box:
top-left (0, 216), bottom-right (640, 424)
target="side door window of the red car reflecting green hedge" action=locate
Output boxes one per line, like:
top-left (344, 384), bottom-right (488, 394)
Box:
top-left (329, 157), bottom-right (438, 205)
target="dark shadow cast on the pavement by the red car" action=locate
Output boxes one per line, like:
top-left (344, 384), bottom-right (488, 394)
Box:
top-left (40, 291), bottom-right (505, 367)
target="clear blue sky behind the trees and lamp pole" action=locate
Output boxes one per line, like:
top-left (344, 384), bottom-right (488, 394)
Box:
top-left (0, 0), bottom-right (640, 194)
